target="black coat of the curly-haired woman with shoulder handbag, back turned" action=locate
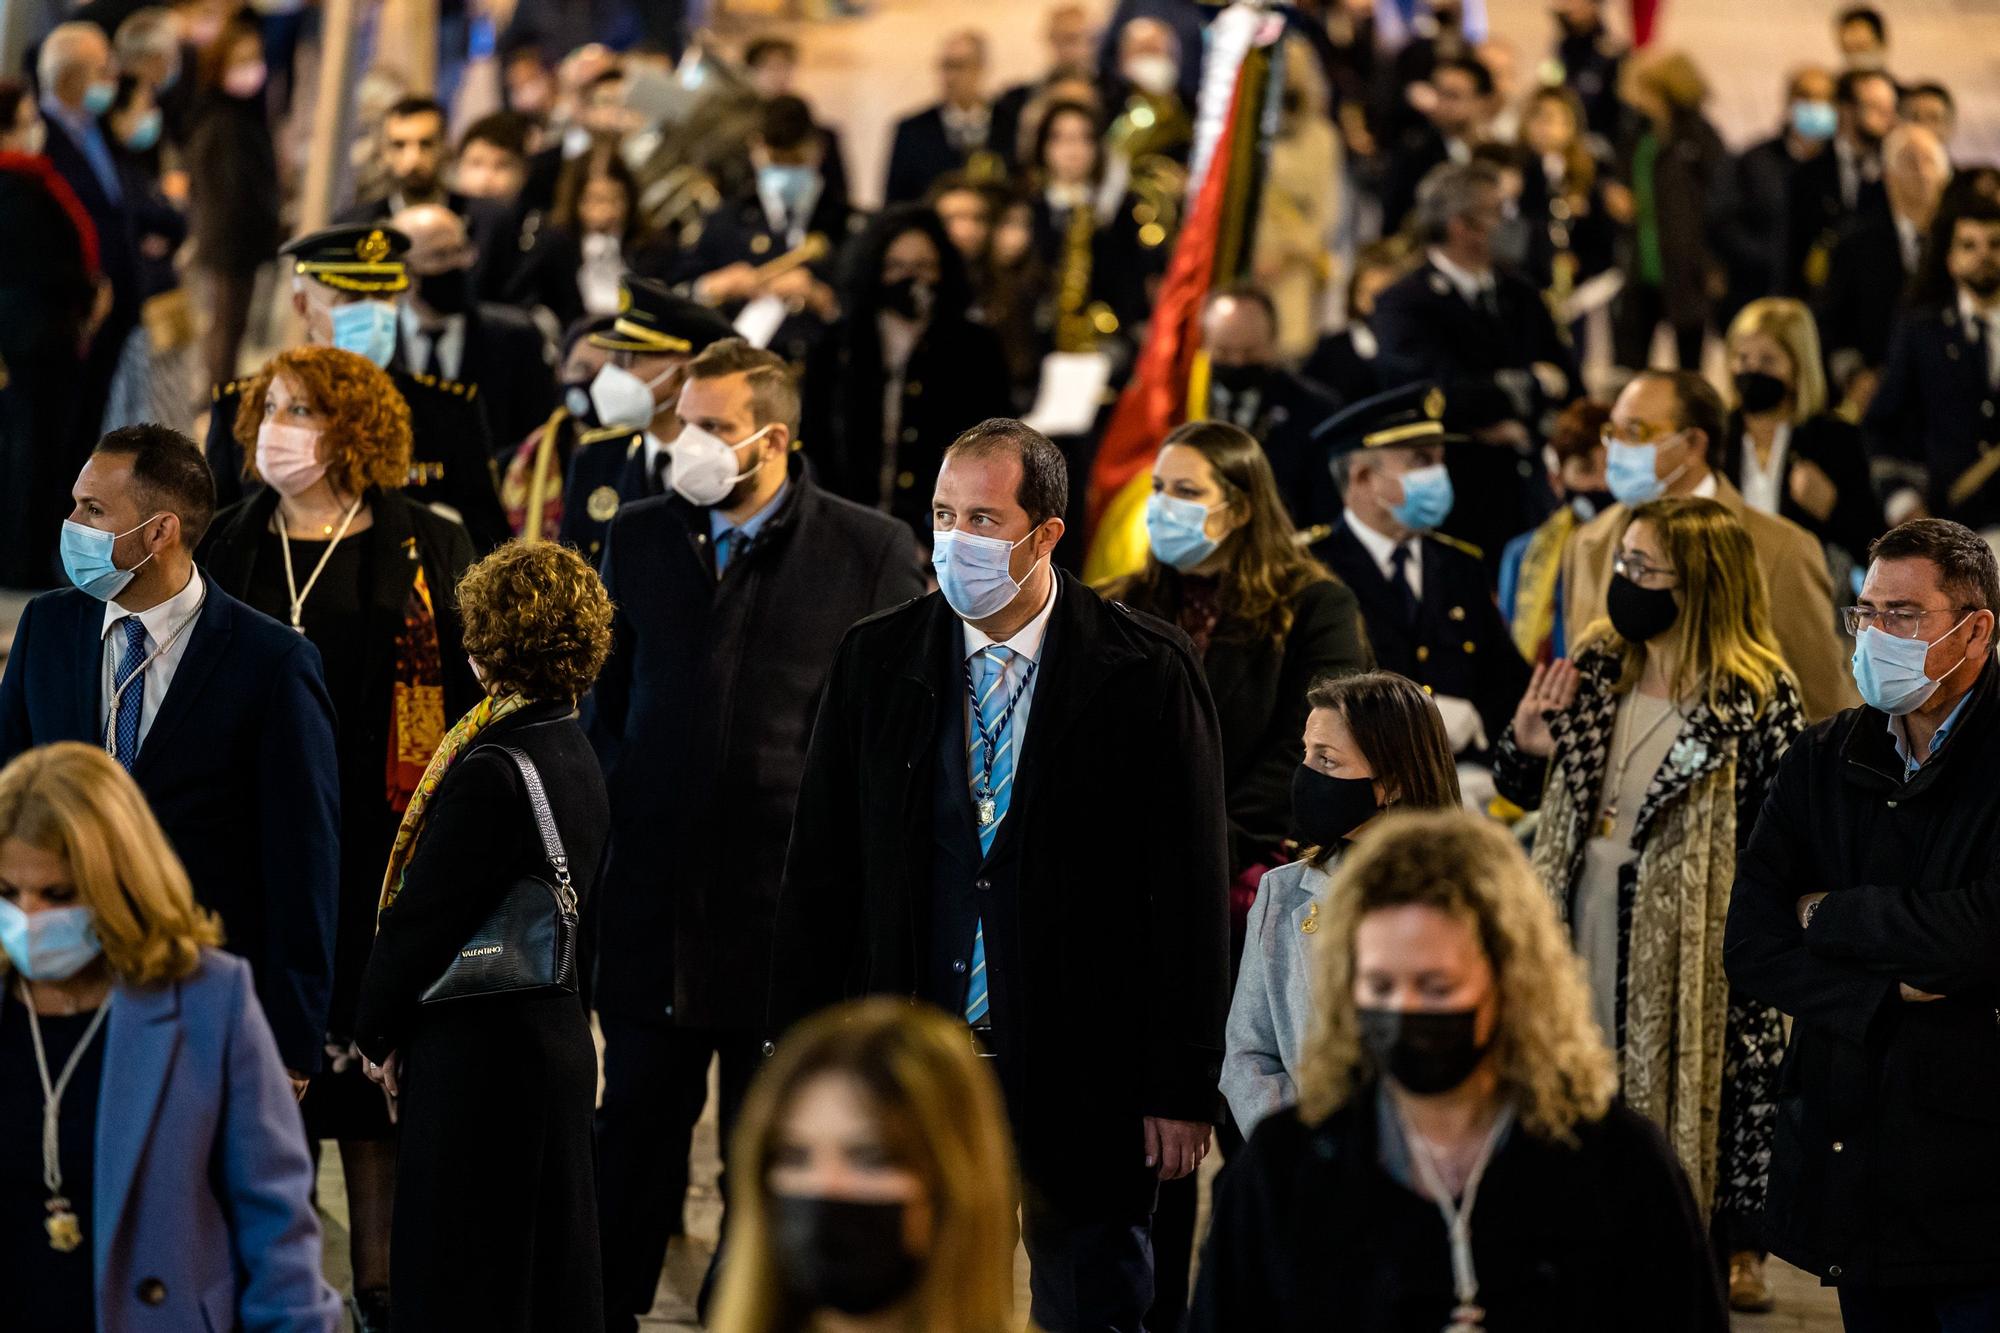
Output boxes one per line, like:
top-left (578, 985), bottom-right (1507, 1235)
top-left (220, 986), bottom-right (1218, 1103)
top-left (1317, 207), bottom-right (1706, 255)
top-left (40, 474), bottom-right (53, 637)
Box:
top-left (356, 703), bottom-right (610, 1333)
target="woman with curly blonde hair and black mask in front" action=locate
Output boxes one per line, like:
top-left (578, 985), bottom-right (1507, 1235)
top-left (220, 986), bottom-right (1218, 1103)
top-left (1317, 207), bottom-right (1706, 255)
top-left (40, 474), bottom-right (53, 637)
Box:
top-left (1190, 811), bottom-right (1728, 1333)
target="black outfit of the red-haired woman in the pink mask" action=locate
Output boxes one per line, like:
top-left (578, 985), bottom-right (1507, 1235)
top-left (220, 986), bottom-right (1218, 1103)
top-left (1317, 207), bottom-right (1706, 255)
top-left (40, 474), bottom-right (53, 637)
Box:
top-left (200, 488), bottom-right (478, 1139)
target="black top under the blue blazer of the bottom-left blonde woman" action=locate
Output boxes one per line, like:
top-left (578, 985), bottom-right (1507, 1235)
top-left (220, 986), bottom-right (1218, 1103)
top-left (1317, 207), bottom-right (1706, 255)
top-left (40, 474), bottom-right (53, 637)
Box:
top-left (0, 985), bottom-right (104, 1333)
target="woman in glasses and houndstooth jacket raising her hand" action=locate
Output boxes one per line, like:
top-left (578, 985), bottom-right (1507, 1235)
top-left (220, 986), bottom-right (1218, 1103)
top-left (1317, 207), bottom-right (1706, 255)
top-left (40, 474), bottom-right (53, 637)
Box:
top-left (1494, 498), bottom-right (1804, 1309)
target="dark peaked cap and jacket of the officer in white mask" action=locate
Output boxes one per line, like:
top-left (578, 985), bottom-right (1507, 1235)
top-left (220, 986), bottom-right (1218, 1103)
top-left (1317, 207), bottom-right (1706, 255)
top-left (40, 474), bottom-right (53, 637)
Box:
top-left (560, 274), bottom-right (734, 564)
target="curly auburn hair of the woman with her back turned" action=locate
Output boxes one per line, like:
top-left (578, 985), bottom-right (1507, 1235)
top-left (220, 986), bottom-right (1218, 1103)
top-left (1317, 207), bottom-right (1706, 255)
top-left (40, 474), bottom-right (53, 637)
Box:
top-left (458, 542), bottom-right (612, 703)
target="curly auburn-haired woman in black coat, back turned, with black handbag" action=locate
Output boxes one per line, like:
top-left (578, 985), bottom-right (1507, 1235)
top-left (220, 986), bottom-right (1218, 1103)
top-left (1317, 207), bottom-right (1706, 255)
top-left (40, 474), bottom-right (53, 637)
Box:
top-left (354, 542), bottom-right (612, 1333)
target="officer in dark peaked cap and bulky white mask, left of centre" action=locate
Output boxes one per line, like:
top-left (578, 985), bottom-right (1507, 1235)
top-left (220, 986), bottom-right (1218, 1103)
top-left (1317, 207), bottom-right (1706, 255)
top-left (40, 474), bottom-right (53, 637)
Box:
top-left (560, 274), bottom-right (730, 564)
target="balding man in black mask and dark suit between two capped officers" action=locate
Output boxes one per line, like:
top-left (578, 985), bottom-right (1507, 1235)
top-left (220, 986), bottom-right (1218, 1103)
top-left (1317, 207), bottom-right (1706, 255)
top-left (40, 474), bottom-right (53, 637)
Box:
top-left (394, 204), bottom-right (556, 462)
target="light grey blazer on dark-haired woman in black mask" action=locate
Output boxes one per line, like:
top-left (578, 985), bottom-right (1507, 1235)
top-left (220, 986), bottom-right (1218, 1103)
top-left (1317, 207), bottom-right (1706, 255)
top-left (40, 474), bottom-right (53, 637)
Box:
top-left (1222, 861), bottom-right (1338, 1137)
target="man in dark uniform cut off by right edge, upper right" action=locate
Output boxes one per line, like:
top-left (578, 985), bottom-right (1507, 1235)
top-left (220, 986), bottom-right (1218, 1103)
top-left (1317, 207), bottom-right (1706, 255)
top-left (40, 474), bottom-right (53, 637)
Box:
top-left (1866, 204), bottom-right (2000, 528)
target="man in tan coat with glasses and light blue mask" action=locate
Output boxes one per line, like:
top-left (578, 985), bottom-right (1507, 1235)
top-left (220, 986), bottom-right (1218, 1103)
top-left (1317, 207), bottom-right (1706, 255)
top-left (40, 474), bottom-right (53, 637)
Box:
top-left (1562, 370), bottom-right (1854, 721)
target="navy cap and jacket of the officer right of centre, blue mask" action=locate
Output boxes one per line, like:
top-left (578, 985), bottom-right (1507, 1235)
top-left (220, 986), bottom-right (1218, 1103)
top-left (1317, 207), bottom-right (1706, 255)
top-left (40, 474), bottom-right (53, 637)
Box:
top-left (1312, 384), bottom-right (1528, 743)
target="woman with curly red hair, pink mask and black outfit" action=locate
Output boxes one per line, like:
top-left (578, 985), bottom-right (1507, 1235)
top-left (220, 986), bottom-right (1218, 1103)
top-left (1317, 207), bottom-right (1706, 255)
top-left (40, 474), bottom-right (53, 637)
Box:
top-left (198, 346), bottom-right (478, 1333)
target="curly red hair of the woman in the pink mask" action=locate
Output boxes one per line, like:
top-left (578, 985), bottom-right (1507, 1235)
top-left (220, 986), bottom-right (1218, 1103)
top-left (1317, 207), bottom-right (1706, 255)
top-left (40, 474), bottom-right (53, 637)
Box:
top-left (234, 346), bottom-right (410, 494)
